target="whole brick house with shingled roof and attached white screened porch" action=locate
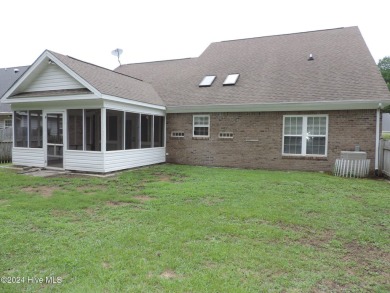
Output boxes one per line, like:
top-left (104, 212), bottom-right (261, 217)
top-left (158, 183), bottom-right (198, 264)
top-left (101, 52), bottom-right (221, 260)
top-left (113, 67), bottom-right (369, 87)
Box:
top-left (4, 27), bottom-right (390, 172)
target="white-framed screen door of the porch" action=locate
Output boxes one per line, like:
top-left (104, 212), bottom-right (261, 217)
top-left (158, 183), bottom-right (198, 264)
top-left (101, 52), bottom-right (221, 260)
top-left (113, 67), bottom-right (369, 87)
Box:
top-left (46, 113), bottom-right (64, 168)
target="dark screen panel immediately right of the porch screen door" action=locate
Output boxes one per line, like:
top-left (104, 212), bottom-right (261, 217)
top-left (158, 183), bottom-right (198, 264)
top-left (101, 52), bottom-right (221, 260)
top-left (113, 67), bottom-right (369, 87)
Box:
top-left (68, 109), bottom-right (83, 151)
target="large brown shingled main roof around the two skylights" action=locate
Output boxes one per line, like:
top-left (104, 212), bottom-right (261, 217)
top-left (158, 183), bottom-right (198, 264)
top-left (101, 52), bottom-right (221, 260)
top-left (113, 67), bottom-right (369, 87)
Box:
top-left (116, 27), bottom-right (390, 107)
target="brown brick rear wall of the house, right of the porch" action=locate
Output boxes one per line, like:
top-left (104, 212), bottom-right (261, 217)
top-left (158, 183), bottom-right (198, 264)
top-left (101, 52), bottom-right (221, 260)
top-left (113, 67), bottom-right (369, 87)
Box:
top-left (167, 110), bottom-right (376, 171)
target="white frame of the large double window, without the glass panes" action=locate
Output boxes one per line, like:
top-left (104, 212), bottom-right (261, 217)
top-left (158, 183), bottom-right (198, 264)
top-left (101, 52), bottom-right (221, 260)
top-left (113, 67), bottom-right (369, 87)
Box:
top-left (282, 114), bottom-right (329, 157)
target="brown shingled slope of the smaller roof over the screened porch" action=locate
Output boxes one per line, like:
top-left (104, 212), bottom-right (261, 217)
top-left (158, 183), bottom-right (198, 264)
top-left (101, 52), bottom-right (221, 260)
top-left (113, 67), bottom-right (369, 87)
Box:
top-left (49, 51), bottom-right (164, 106)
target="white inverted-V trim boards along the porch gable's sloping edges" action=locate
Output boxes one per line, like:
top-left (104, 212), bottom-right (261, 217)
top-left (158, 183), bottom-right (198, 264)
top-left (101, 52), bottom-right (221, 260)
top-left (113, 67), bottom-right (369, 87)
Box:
top-left (3, 50), bottom-right (102, 103)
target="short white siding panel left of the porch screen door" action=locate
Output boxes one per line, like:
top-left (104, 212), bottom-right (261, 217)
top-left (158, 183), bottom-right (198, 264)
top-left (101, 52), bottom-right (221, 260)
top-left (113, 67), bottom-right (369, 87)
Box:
top-left (12, 148), bottom-right (45, 167)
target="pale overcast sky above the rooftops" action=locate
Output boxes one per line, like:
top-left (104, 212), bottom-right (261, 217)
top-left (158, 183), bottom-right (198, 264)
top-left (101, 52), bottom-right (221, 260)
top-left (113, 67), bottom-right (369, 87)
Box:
top-left (0, 0), bottom-right (390, 69)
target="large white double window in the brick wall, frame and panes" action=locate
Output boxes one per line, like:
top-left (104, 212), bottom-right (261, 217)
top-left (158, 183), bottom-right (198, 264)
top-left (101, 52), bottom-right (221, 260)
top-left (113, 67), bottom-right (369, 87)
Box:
top-left (283, 115), bottom-right (328, 156)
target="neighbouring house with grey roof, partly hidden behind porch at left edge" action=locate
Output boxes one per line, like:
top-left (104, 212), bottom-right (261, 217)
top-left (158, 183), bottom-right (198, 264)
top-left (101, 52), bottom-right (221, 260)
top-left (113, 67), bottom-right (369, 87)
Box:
top-left (0, 66), bottom-right (28, 130)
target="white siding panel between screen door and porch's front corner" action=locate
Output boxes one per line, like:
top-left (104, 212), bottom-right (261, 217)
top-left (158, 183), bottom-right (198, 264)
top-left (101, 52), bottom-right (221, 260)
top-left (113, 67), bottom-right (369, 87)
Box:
top-left (64, 151), bottom-right (104, 173)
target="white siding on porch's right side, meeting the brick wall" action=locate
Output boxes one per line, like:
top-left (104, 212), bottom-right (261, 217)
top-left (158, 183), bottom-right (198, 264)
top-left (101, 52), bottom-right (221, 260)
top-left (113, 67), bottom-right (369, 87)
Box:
top-left (104, 148), bottom-right (165, 172)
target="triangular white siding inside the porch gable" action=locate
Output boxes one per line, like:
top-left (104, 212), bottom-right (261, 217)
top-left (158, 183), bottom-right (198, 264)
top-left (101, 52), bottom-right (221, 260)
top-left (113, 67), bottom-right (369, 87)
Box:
top-left (25, 65), bottom-right (84, 92)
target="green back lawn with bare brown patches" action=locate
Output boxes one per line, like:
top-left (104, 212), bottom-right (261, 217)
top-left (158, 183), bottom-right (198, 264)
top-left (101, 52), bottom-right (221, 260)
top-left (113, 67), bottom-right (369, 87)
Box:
top-left (0, 165), bottom-right (390, 292)
